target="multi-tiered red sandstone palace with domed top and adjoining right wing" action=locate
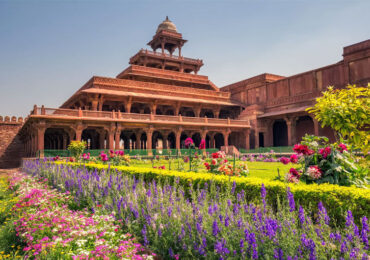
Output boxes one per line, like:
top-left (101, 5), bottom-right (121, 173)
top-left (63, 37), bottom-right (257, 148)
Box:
top-left (0, 18), bottom-right (370, 167)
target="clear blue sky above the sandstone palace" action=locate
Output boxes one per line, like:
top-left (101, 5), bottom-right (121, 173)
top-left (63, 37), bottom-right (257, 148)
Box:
top-left (0, 0), bottom-right (370, 116)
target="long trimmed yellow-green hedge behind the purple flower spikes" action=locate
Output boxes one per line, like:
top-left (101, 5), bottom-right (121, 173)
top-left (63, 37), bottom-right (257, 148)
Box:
top-left (55, 162), bottom-right (370, 225)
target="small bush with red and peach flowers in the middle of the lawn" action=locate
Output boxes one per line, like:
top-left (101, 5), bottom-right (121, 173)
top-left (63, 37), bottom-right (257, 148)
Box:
top-left (204, 151), bottom-right (249, 176)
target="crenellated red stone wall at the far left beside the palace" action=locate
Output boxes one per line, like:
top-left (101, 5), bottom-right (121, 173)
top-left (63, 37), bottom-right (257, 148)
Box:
top-left (0, 116), bottom-right (24, 169)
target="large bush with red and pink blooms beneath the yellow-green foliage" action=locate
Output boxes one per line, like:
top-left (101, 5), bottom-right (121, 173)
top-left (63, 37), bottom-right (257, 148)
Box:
top-left (282, 135), bottom-right (368, 187)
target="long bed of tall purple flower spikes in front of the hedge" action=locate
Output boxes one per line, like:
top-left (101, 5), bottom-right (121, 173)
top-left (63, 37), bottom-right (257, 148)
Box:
top-left (24, 160), bottom-right (369, 259)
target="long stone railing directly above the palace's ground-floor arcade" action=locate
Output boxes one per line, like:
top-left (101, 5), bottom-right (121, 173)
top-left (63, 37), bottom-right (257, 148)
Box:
top-left (31, 106), bottom-right (250, 128)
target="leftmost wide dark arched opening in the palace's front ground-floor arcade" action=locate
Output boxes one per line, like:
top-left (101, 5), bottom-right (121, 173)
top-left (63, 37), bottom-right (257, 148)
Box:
top-left (44, 128), bottom-right (70, 150)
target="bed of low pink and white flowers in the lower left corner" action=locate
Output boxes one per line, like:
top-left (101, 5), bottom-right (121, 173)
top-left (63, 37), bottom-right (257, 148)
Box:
top-left (1, 173), bottom-right (152, 259)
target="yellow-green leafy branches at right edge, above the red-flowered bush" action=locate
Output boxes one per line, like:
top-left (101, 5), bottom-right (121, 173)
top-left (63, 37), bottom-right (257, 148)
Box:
top-left (308, 83), bottom-right (370, 155)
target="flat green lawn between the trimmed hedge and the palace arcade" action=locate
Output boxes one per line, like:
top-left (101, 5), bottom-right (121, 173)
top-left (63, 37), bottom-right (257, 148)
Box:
top-left (130, 160), bottom-right (297, 180)
